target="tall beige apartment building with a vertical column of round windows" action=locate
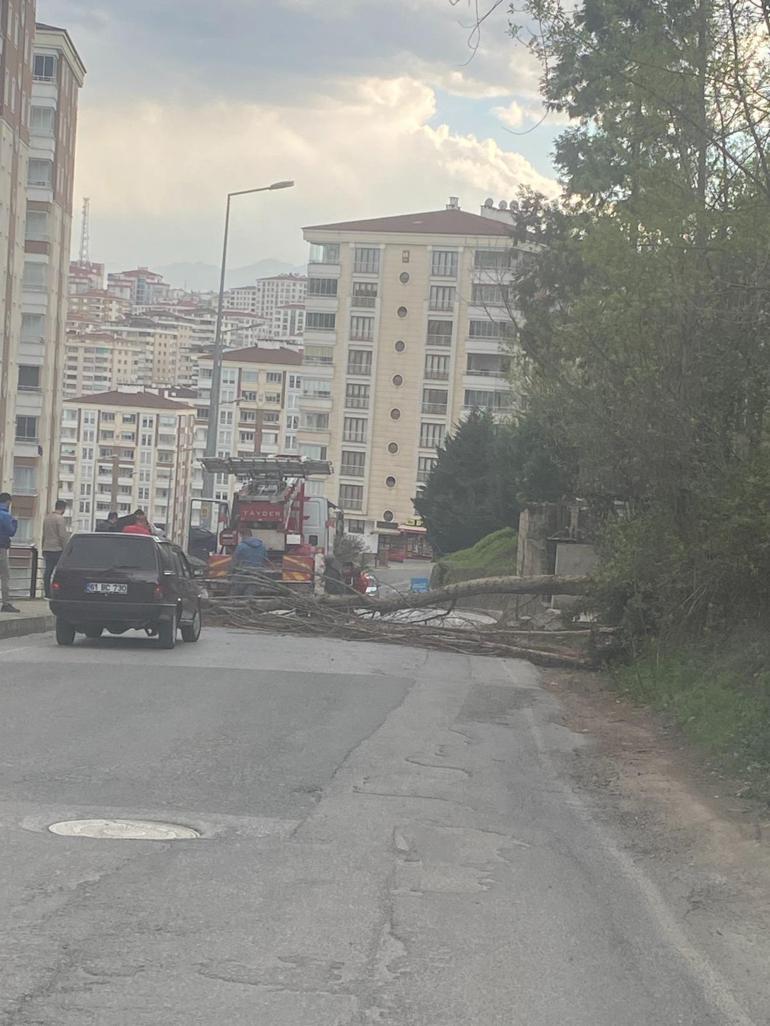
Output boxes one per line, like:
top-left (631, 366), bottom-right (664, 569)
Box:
top-left (299, 200), bottom-right (518, 551)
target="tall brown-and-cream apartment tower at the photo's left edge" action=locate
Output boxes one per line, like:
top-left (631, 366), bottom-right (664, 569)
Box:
top-left (0, 14), bottom-right (85, 542)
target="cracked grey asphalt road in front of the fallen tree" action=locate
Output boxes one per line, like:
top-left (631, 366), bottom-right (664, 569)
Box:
top-left (0, 630), bottom-right (767, 1026)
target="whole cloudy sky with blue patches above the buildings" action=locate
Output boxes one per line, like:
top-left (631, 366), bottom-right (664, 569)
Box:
top-left (37, 0), bottom-right (561, 267)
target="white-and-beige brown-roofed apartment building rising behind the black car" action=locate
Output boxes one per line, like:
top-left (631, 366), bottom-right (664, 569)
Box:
top-left (57, 390), bottom-right (195, 544)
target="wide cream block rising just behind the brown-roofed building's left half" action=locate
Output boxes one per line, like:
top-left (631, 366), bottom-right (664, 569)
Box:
top-left (63, 331), bottom-right (153, 399)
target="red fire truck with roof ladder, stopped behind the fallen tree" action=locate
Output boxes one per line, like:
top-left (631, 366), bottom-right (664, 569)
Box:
top-left (203, 456), bottom-right (343, 585)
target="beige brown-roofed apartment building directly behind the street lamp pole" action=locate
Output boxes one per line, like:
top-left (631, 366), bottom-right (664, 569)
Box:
top-left (193, 346), bottom-right (302, 499)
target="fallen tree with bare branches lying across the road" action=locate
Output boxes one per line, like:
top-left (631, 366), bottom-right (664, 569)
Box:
top-left (203, 575), bottom-right (593, 668)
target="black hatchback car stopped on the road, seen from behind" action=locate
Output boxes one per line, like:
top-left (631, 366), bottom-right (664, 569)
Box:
top-left (50, 532), bottom-right (204, 648)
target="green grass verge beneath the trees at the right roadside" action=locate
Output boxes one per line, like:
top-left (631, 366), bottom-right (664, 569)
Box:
top-left (614, 636), bottom-right (770, 798)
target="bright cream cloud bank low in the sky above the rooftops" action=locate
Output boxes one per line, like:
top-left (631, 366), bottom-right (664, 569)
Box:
top-left (77, 77), bottom-right (555, 265)
